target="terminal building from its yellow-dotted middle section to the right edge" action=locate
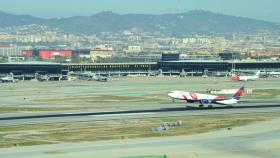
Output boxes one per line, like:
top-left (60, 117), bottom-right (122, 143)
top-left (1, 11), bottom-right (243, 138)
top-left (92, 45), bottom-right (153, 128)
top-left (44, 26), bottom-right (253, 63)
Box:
top-left (64, 61), bottom-right (280, 72)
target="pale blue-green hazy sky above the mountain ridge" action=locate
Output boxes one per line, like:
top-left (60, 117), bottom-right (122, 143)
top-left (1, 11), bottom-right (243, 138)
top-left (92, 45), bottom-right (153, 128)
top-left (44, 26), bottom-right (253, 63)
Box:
top-left (0, 0), bottom-right (280, 23)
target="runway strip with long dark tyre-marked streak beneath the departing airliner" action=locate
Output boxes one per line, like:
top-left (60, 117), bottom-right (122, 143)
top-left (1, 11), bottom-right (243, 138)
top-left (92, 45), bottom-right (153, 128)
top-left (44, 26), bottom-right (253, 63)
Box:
top-left (0, 103), bottom-right (280, 126)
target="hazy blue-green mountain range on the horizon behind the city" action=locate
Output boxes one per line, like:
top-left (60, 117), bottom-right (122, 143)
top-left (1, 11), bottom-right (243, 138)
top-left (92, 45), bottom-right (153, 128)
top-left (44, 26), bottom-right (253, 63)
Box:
top-left (0, 10), bottom-right (279, 36)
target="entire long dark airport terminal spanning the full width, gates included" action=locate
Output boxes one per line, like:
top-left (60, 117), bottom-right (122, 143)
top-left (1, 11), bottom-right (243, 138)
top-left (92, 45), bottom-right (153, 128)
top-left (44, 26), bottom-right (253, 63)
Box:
top-left (0, 57), bottom-right (280, 80)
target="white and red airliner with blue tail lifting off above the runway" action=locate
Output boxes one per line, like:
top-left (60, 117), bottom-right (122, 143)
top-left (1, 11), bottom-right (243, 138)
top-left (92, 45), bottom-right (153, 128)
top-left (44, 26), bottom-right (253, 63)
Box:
top-left (168, 86), bottom-right (245, 107)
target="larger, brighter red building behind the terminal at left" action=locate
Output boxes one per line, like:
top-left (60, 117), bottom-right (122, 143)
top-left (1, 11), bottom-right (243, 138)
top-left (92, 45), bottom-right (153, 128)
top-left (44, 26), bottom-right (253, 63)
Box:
top-left (39, 50), bottom-right (72, 59)
